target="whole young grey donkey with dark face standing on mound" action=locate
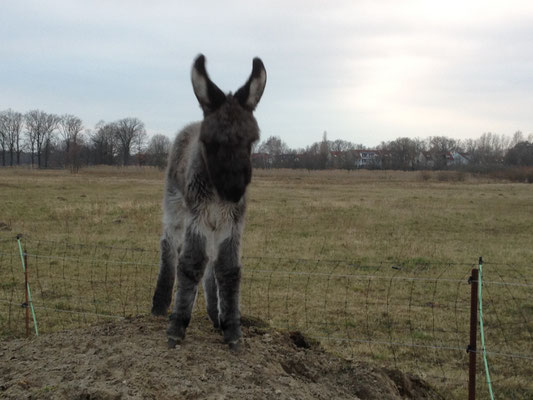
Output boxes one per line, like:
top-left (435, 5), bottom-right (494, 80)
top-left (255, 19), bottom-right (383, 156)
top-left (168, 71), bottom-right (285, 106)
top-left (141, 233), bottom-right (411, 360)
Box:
top-left (152, 55), bottom-right (266, 349)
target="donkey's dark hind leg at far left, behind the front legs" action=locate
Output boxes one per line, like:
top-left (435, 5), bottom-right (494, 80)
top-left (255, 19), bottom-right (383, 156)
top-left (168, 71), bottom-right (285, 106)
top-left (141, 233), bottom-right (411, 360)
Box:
top-left (152, 237), bottom-right (177, 316)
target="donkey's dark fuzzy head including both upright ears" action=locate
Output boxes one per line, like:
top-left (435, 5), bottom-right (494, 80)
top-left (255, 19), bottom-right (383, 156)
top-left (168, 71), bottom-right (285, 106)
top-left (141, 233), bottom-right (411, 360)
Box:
top-left (191, 55), bottom-right (266, 202)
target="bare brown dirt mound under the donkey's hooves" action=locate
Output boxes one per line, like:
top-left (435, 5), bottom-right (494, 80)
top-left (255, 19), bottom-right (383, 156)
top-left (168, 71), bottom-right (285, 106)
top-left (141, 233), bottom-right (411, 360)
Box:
top-left (0, 317), bottom-right (442, 400)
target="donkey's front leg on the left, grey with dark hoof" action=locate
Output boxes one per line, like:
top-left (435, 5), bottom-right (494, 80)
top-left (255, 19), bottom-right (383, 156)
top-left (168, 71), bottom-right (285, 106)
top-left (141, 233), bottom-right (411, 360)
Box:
top-left (167, 227), bottom-right (207, 348)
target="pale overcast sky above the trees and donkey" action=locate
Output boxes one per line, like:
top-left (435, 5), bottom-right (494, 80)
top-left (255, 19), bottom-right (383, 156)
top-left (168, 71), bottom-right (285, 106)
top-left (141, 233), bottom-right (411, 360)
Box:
top-left (0, 0), bottom-right (533, 148)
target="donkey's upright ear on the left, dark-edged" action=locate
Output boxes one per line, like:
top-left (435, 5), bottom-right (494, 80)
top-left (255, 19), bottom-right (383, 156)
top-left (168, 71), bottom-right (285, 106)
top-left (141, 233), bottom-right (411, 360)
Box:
top-left (191, 54), bottom-right (226, 114)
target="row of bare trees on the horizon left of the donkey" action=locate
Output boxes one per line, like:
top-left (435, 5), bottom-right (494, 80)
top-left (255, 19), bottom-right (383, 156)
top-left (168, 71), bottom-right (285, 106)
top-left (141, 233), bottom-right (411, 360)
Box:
top-left (0, 109), bottom-right (170, 172)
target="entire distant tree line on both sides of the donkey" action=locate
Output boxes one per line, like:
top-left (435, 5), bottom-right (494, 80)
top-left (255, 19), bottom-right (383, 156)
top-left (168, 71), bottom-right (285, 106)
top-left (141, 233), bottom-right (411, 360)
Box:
top-left (0, 109), bottom-right (533, 172)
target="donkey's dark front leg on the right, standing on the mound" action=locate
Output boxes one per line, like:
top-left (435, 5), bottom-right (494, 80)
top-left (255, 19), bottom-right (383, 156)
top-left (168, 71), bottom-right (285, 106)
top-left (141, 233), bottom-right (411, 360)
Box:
top-left (214, 235), bottom-right (242, 350)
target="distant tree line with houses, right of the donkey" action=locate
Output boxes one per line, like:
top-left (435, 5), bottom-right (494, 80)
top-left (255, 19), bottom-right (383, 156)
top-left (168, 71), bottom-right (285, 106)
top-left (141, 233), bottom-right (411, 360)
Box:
top-left (253, 131), bottom-right (533, 171)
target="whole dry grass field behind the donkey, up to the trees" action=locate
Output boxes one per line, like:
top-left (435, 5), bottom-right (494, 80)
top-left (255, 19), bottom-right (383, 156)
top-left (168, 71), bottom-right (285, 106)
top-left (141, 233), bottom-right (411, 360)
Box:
top-left (0, 167), bottom-right (533, 398)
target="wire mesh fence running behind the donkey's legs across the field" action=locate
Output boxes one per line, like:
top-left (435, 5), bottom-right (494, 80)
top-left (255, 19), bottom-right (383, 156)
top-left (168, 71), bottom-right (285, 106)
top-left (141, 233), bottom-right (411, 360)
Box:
top-left (0, 237), bottom-right (533, 399)
